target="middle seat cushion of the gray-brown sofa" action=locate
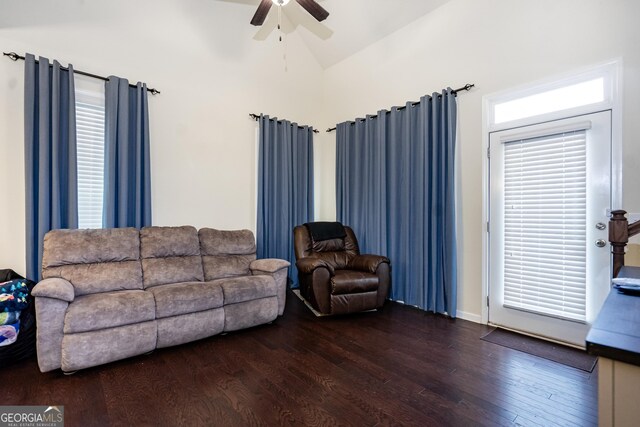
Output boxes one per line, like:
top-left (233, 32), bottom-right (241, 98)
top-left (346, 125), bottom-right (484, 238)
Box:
top-left (148, 282), bottom-right (224, 319)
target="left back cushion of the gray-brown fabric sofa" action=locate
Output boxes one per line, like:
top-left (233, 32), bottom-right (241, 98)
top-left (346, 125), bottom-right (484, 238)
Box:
top-left (42, 228), bottom-right (142, 296)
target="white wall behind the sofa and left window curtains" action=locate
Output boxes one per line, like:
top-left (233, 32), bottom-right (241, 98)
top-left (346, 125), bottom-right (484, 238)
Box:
top-left (0, 0), bottom-right (322, 274)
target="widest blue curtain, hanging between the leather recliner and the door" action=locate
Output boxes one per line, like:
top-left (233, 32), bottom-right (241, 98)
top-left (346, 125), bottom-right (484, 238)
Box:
top-left (336, 88), bottom-right (457, 317)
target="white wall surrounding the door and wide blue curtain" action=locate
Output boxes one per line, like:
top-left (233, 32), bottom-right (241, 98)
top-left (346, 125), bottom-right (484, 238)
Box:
top-left (318, 0), bottom-right (640, 320)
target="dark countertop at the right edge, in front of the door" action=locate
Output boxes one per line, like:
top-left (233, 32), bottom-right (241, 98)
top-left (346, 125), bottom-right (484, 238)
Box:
top-left (586, 267), bottom-right (640, 366)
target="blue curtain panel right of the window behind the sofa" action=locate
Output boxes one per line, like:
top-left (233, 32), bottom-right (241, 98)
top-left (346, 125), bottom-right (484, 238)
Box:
top-left (103, 76), bottom-right (151, 228)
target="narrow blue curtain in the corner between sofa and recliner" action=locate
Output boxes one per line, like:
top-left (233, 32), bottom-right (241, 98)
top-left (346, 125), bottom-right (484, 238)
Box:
top-left (256, 115), bottom-right (313, 286)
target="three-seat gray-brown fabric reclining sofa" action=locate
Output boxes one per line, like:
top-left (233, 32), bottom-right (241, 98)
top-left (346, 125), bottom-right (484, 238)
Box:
top-left (32, 226), bottom-right (289, 372)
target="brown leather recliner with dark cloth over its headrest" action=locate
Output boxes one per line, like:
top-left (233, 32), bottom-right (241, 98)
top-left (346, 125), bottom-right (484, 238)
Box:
top-left (293, 222), bottom-right (391, 314)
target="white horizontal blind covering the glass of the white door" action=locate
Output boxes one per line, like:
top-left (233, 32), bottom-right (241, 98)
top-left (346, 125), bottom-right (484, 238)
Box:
top-left (504, 130), bottom-right (587, 321)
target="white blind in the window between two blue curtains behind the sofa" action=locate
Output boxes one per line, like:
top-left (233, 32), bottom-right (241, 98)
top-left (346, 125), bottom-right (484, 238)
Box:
top-left (76, 90), bottom-right (104, 228)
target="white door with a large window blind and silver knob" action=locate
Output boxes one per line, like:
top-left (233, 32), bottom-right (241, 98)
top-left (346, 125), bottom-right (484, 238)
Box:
top-left (489, 111), bottom-right (611, 346)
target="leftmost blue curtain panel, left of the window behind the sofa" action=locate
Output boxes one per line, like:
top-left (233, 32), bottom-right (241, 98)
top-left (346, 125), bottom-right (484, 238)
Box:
top-left (24, 54), bottom-right (78, 281)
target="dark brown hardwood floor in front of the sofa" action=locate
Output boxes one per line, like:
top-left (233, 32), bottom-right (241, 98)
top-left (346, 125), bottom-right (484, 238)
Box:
top-left (0, 294), bottom-right (597, 426)
